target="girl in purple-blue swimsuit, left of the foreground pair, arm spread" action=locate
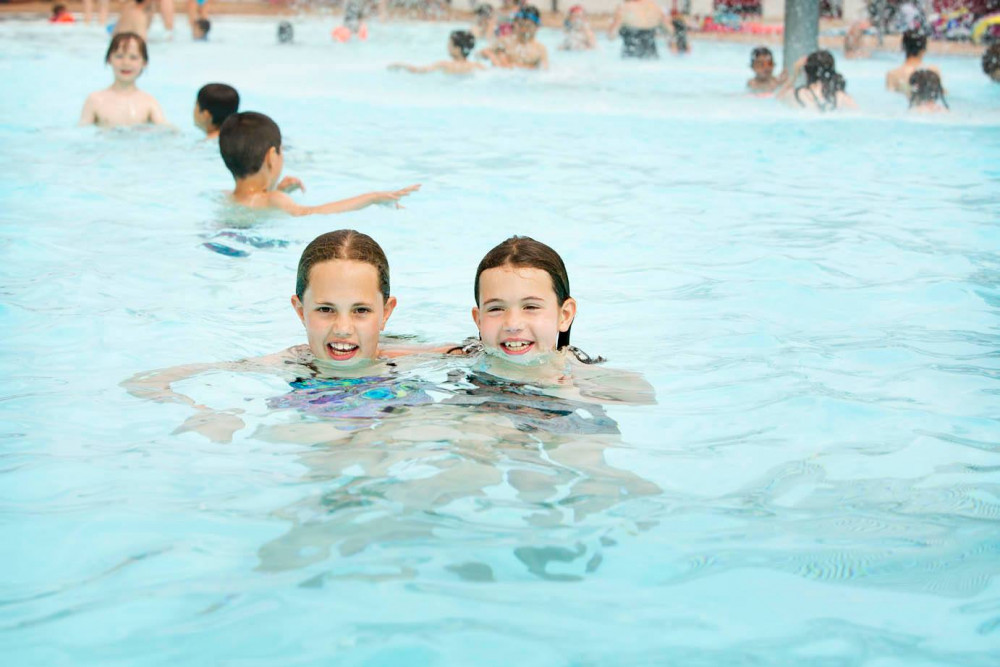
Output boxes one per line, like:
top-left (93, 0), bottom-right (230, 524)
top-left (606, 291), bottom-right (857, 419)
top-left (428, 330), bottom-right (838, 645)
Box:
top-left (122, 229), bottom-right (442, 442)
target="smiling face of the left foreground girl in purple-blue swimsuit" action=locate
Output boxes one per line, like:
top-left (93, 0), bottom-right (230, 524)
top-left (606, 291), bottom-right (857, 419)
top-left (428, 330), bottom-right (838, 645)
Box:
top-left (292, 259), bottom-right (396, 366)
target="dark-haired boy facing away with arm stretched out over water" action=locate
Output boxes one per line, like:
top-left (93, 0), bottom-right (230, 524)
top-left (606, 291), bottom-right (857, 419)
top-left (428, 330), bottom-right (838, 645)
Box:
top-left (219, 111), bottom-right (420, 216)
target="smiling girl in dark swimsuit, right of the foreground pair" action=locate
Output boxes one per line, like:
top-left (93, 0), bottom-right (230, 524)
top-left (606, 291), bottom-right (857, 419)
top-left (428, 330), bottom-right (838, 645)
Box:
top-left (449, 236), bottom-right (656, 405)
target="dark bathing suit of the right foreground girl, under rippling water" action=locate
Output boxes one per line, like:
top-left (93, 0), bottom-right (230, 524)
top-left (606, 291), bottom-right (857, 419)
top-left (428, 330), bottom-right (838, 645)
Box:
top-left (444, 373), bottom-right (619, 435)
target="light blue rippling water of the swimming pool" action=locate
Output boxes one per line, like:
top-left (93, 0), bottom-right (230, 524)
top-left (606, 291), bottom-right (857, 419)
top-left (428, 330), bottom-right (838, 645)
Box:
top-left (0, 17), bottom-right (1000, 665)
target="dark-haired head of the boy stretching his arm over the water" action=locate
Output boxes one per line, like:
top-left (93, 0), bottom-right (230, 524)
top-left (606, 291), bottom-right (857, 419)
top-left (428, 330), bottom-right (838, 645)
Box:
top-left (219, 111), bottom-right (283, 187)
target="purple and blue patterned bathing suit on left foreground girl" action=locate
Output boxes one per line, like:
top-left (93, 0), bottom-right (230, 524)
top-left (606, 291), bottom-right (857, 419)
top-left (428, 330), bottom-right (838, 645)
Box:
top-left (267, 376), bottom-right (434, 430)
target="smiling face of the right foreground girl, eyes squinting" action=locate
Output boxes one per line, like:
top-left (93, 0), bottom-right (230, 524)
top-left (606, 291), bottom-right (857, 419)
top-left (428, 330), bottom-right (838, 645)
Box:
top-left (472, 266), bottom-right (576, 361)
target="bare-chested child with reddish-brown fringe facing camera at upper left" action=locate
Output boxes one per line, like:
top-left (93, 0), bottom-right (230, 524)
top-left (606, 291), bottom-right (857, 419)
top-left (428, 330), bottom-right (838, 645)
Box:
top-left (79, 32), bottom-right (167, 127)
